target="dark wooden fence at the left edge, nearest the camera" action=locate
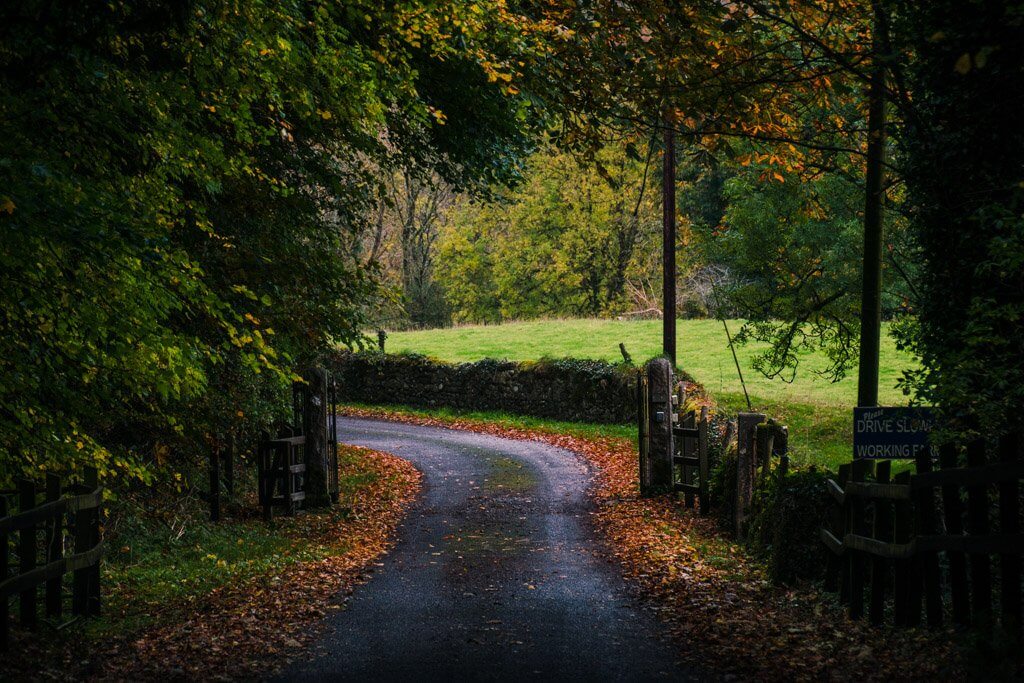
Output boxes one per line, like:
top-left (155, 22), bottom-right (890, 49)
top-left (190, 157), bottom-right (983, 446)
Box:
top-left (0, 468), bottom-right (103, 649)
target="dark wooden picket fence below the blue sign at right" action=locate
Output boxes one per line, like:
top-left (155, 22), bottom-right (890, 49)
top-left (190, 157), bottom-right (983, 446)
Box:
top-left (821, 434), bottom-right (1024, 629)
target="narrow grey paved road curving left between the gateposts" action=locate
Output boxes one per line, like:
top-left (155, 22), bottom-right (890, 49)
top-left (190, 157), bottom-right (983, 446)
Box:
top-left (286, 419), bottom-right (700, 681)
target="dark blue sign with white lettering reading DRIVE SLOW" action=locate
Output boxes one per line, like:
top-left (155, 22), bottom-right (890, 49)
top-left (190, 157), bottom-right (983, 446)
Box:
top-left (853, 408), bottom-right (935, 460)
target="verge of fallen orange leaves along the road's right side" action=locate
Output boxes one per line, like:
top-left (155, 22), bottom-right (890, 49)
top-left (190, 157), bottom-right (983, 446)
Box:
top-left (345, 408), bottom-right (967, 681)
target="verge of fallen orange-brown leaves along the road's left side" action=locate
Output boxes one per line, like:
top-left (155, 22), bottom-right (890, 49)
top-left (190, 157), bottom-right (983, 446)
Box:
top-left (0, 445), bottom-right (422, 680)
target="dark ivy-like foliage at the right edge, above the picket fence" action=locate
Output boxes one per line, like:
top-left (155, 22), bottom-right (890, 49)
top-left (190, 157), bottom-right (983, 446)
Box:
top-left (895, 0), bottom-right (1024, 433)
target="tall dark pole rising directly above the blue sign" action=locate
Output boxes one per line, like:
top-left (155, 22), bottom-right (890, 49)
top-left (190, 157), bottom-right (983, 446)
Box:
top-left (857, 0), bottom-right (889, 407)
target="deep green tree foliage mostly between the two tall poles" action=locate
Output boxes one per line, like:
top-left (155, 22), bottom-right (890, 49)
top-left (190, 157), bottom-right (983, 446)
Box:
top-left (700, 153), bottom-right (915, 381)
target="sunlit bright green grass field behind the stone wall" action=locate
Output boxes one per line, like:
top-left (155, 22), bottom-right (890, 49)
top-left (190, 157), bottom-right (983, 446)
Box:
top-left (387, 319), bottom-right (914, 466)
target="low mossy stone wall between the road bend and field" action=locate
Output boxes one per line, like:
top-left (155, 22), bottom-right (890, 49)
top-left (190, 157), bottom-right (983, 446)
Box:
top-left (328, 351), bottom-right (637, 424)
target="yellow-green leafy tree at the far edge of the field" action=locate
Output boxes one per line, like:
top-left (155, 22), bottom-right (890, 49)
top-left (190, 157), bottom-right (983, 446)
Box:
top-left (437, 145), bottom-right (657, 323)
